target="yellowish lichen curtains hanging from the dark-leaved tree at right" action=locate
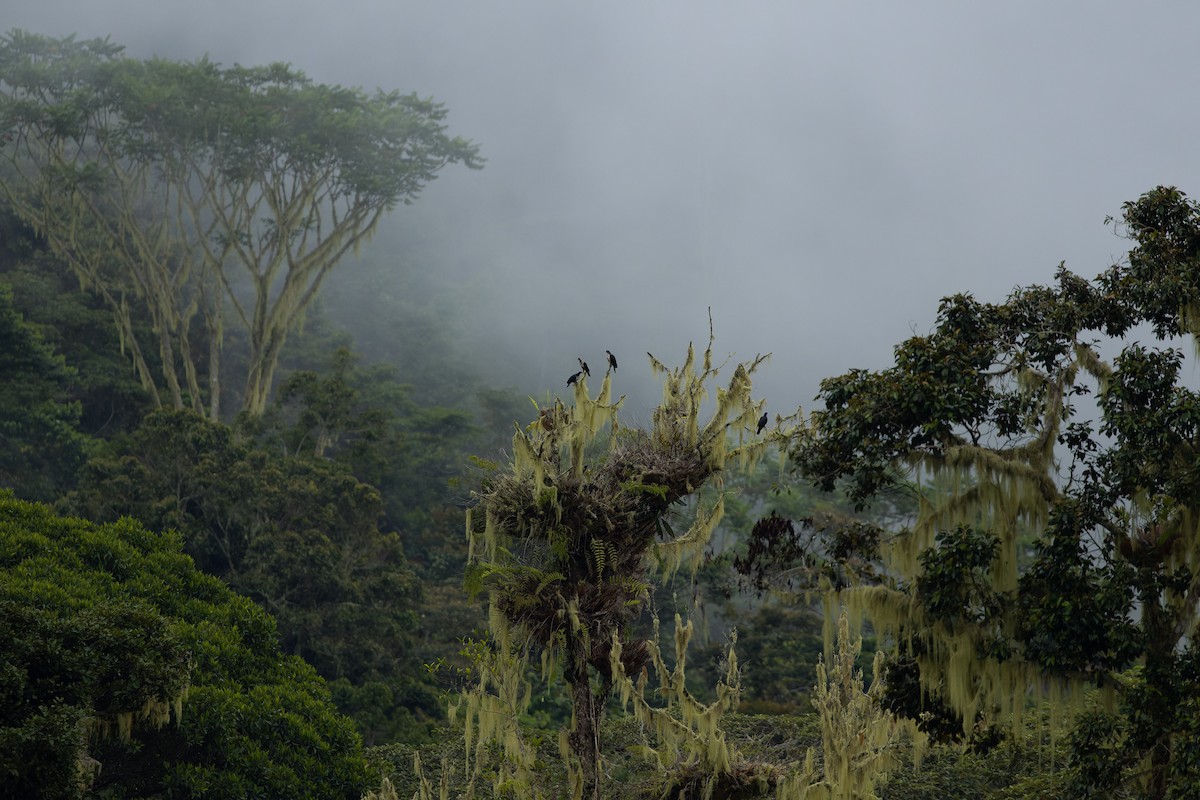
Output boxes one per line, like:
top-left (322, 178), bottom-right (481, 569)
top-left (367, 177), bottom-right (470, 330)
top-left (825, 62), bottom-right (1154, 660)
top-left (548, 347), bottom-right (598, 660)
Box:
top-left (830, 348), bottom-right (1105, 758)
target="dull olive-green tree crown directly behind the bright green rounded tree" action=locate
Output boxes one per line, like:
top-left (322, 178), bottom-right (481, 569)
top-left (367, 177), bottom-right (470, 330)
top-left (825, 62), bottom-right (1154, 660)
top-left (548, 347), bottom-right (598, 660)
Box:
top-left (71, 409), bottom-right (433, 735)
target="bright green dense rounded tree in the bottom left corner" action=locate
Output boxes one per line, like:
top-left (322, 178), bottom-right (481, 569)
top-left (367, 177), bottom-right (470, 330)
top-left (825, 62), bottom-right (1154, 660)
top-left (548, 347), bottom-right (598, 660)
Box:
top-left (0, 494), bottom-right (368, 800)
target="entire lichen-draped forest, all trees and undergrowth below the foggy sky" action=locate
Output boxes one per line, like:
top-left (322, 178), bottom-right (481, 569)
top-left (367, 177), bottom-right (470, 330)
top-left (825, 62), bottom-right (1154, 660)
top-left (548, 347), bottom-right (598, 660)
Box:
top-left (0, 31), bottom-right (1200, 800)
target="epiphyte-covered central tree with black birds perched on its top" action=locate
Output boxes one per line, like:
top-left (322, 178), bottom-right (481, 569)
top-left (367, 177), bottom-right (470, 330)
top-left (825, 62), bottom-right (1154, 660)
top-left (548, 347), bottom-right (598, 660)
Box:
top-left (466, 342), bottom-right (764, 796)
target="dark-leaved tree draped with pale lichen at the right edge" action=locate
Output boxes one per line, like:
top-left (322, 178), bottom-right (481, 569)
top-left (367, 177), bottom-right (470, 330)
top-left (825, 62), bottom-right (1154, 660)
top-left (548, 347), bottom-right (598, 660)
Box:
top-left (791, 187), bottom-right (1200, 800)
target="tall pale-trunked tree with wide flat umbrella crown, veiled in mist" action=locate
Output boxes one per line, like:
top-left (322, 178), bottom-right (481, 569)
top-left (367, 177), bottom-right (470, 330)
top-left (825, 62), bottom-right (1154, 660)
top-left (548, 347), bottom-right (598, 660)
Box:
top-left (0, 31), bottom-right (482, 419)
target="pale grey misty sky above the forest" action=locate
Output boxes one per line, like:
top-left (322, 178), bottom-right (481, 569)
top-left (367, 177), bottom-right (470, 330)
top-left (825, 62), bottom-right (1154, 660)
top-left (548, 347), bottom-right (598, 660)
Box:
top-left (9, 0), bottom-right (1200, 413)
